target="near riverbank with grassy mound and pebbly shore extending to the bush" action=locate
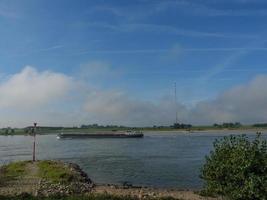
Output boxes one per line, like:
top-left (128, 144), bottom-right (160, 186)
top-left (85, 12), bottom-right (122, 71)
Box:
top-left (0, 161), bottom-right (220, 200)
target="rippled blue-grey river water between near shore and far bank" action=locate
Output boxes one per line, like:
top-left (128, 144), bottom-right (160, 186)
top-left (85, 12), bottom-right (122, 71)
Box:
top-left (0, 131), bottom-right (267, 189)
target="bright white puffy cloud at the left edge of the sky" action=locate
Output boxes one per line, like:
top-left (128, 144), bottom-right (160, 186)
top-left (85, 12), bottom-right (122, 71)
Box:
top-left (0, 66), bottom-right (72, 109)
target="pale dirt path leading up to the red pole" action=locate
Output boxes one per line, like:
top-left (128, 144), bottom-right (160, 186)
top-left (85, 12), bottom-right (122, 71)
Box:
top-left (0, 162), bottom-right (40, 195)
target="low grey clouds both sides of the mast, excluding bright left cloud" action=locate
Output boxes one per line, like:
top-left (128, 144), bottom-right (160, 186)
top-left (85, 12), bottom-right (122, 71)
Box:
top-left (84, 76), bottom-right (267, 126)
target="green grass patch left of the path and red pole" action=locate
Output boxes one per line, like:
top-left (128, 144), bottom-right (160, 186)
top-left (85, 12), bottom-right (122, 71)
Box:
top-left (0, 161), bottom-right (29, 185)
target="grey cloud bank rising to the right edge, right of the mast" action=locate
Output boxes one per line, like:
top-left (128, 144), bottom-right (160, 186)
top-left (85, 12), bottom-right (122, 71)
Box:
top-left (190, 75), bottom-right (267, 124)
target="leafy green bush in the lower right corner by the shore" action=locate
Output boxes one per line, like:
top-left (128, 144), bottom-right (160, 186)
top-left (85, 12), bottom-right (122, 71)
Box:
top-left (201, 133), bottom-right (267, 200)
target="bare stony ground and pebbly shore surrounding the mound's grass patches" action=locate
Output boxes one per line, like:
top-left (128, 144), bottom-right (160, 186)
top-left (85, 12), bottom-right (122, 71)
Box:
top-left (0, 161), bottom-right (220, 200)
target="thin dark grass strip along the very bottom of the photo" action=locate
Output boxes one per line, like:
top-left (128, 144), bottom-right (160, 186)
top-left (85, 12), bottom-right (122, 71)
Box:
top-left (0, 194), bottom-right (180, 200)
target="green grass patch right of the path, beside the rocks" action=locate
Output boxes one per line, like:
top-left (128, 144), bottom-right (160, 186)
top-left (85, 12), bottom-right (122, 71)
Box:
top-left (37, 160), bottom-right (75, 183)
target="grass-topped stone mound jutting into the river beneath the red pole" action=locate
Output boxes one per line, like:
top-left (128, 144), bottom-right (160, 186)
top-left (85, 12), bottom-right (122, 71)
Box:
top-left (0, 161), bottom-right (93, 196)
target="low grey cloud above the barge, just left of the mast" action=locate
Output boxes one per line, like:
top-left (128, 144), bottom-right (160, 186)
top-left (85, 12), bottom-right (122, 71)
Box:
top-left (84, 91), bottom-right (186, 126)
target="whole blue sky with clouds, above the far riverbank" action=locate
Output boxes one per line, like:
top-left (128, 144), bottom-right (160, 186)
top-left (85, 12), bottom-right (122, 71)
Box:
top-left (0, 0), bottom-right (267, 127)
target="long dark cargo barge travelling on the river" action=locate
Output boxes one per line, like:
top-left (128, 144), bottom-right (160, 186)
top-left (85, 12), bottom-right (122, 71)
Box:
top-left (57, 131), bottom-right (144, 139)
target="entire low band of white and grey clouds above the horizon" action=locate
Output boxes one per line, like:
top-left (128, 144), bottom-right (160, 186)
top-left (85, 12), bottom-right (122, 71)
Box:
top-left (0, 67), bottom-right (267, 127)
